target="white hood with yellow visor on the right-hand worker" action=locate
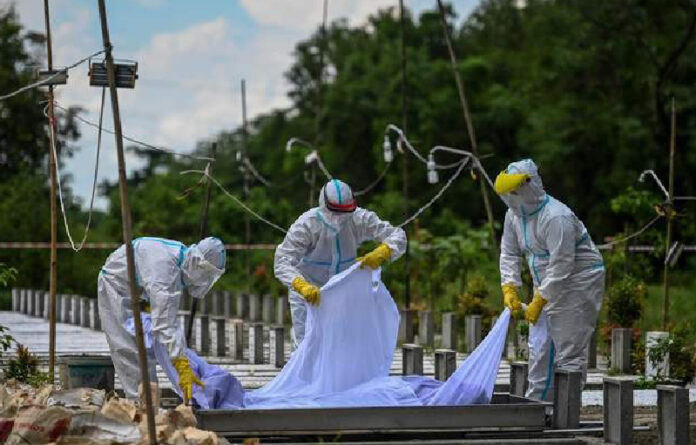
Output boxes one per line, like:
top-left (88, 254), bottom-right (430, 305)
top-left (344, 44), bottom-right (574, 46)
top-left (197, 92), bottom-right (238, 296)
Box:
top-left (500, 159), bottom-right (548, 215)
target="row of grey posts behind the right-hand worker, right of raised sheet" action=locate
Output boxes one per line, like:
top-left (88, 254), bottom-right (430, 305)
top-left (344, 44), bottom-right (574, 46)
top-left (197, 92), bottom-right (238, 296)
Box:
top-left (399, 310), bottom-right (597, 369)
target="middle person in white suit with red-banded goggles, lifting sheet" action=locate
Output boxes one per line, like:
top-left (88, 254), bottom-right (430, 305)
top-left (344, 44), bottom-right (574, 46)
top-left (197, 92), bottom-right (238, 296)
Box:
top-left (274, 179), bottom-right (406, 346)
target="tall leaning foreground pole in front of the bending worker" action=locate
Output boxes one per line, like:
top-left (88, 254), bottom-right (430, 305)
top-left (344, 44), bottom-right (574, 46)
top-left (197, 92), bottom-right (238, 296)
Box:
top-left (97, 0), bottom-right (157, 445)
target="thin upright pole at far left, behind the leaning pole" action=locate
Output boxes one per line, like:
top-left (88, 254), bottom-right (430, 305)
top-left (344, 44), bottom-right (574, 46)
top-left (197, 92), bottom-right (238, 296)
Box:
top-left (44, 0), bottom-right (58, 382)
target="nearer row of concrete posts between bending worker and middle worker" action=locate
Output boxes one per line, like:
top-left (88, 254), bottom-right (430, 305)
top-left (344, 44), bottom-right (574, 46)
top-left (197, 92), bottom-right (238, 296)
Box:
top-left (179, 310), bottom-right (285, 368)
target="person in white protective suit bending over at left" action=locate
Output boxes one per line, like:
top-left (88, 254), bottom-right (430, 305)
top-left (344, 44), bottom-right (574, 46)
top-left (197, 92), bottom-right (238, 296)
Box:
top-left (98, 237), bottom-right (225, 401)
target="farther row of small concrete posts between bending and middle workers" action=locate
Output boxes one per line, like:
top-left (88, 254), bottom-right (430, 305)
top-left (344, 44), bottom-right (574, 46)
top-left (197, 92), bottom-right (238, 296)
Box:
top-left (179, 291), bottom-right (288, 325)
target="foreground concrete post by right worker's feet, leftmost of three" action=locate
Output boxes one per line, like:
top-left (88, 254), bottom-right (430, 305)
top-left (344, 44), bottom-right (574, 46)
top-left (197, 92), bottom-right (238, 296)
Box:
top-left (553, 369), bottom-right (582, 429)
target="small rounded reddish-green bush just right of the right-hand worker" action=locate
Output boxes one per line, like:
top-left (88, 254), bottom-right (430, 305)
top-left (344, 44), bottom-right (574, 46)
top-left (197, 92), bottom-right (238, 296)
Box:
top-left (606, 276), bottom-right (645, 328)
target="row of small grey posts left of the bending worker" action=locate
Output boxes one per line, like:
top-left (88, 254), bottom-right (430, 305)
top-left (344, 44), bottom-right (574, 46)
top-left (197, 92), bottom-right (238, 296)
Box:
top-left (12, 288), bottom-right (101, 331)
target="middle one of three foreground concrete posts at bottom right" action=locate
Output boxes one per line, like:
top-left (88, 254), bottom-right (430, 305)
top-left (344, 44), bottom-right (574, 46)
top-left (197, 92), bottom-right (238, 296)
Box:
top-left (604, 377), bottom-right (633, 445)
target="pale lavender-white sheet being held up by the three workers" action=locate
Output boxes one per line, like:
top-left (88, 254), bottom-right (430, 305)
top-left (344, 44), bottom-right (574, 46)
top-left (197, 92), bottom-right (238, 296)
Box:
top-left (132, 265), bottom-right (510, 409)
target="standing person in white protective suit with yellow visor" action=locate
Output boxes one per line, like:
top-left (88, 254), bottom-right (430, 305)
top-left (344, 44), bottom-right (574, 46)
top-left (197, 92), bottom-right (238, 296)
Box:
top-left (494, 159), bottom-right (604, 400)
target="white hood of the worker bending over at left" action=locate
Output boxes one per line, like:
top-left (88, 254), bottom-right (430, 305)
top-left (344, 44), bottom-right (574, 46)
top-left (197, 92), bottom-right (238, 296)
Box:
top-left (181, 237), bottom-right (225, 298)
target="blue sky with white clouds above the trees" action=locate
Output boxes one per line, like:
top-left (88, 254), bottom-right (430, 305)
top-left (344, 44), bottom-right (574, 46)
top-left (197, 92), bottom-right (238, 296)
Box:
top-left (0, 0), bottom-right (479, 208)
